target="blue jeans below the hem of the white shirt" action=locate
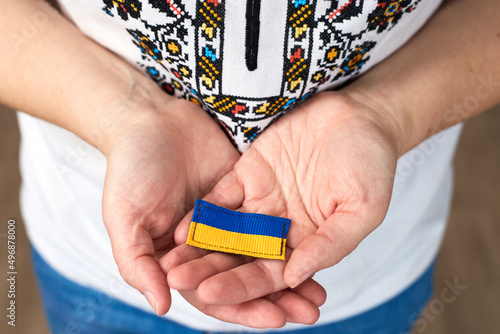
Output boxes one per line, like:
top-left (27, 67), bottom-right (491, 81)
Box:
top-left (32, 245), bottom-right (434, 334)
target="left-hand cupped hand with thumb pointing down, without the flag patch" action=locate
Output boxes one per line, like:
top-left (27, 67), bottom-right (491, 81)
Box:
top-left (103, 93), bottom-right (240, 314)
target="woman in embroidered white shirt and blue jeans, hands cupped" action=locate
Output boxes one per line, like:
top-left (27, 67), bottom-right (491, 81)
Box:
top-left (0, 0), bottom-right (500, 333)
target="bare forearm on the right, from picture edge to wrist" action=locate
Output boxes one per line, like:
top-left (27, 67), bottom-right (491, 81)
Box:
top-left (343, 0), bottom-right (500, 155)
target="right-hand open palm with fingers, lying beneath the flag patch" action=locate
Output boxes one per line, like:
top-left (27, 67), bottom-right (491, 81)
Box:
top-left (164, 92), bottom-right (398, 326)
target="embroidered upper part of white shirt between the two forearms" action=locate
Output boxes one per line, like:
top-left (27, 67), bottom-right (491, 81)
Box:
top-left (66, 0), bottom-right (430, 151)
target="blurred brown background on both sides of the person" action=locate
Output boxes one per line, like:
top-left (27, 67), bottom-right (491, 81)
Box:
top-left (0, 105), bottom-right (500, 334)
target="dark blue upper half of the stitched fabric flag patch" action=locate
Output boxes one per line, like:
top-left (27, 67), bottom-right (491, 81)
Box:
top-left (193, 199), bottom-right (290, 238)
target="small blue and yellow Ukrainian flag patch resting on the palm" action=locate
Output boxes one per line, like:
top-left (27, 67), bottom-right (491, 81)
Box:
top-left (187, 199), bottom-right (290, 260)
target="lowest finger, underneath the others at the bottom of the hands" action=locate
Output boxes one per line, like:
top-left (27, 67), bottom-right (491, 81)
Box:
top-left (179, 290), bottom-right (287, 328)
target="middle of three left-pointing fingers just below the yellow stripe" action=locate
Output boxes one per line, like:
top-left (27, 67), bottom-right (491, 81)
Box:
top-left (167, 250), bottom-right (250, 290)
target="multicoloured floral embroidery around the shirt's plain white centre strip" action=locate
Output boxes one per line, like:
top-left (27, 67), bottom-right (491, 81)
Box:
top-left (103, 0), bottom-right (421, 151)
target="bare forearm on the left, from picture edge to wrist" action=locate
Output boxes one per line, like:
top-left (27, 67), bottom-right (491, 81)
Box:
top-left (0, 0), bottom-right (163, 151)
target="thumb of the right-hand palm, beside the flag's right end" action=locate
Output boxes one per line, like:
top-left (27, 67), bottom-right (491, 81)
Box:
top-left (284, 212), bottom-right (373, 288)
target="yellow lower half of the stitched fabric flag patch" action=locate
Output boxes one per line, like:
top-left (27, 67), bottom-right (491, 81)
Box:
top-left (187, 222), bottom-right (286, 260)
